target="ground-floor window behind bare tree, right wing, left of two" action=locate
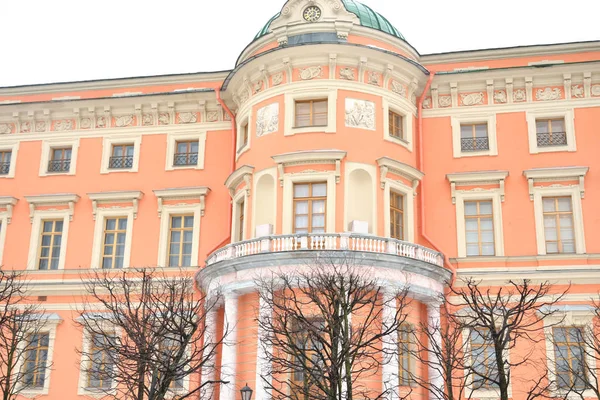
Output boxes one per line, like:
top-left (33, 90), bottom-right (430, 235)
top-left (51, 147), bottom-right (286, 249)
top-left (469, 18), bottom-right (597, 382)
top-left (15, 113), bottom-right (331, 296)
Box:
top-left (469, 329), bottom-right (498, 389)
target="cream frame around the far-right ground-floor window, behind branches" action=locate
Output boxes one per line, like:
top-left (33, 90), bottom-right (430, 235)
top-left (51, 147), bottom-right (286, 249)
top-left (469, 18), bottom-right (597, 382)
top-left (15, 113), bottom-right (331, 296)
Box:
top-left (544, 305), bottom-right (596, 399)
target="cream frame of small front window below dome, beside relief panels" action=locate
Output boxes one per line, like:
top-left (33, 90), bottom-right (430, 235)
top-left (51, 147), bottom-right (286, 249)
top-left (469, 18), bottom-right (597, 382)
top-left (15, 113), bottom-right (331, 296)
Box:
top-left (283, 87), bottom-right (338, 136)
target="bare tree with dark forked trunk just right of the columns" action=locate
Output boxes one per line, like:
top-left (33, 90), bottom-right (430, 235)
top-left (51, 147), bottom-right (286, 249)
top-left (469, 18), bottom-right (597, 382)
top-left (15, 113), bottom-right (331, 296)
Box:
top-left (449, 279), bottom-right (568, 400)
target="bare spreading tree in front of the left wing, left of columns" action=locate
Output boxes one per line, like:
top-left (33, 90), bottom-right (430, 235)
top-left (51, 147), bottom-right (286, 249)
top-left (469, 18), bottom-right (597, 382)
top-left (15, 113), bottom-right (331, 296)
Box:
top-left (77, 269), bottom-right (227, 400)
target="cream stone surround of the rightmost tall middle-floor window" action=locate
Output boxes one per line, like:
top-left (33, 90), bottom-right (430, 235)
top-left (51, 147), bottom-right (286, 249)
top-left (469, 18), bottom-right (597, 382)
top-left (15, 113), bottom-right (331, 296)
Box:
top-left (532, 185), bottom-right (585, 255)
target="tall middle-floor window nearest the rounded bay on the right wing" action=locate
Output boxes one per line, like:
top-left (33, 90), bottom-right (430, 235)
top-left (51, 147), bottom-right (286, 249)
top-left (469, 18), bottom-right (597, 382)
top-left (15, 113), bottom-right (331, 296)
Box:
top-left (465, 200), bottom-right (495, 256)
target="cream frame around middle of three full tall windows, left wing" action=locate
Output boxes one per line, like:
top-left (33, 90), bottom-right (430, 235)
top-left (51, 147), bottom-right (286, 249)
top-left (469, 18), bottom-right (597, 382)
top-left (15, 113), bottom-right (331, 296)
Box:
top-left (90, 206), bottom-right (134, 269)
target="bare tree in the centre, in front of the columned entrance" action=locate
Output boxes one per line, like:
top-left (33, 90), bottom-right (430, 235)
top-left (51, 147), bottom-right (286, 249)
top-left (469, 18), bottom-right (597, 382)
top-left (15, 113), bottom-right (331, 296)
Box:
top-left (257, 252), bottom-right (408, 400)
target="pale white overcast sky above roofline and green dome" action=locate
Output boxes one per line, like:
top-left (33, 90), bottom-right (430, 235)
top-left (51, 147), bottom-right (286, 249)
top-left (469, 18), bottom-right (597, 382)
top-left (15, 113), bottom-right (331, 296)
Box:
top-left (0, 0), bottom-right (600, 86)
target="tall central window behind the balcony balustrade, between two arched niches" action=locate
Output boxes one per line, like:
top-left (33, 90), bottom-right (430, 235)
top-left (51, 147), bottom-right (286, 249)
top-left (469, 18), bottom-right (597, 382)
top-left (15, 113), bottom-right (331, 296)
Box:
top-left (294, 183), bottom-right (327, 233)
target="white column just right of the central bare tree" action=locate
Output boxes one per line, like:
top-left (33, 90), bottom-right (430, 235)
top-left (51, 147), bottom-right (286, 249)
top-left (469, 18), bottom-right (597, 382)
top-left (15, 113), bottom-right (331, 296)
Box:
top-left (381, 289), bottom-right (400, 400)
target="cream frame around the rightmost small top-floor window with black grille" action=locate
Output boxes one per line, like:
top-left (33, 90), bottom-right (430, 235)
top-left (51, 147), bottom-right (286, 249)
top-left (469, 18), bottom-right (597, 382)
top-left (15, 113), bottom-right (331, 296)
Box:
top-left (526, 108), bottom-right (577, 154)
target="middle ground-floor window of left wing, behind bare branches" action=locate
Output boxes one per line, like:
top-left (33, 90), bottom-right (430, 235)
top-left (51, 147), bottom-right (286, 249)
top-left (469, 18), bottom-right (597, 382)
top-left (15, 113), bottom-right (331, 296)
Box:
top-left (87, 334), bottom-right (114, 389)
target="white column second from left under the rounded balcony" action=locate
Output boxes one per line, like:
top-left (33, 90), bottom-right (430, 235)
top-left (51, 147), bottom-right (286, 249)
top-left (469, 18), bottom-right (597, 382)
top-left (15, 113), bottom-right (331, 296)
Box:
top-left (219, 293), bottom-right (238, 400)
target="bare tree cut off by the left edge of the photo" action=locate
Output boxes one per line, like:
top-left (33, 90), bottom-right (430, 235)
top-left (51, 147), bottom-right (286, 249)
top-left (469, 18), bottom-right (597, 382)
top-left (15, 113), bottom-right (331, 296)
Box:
top-left (0, 270), bottom-right (51, 400)
